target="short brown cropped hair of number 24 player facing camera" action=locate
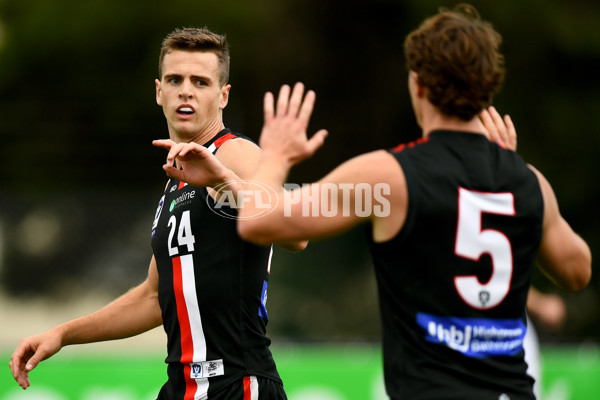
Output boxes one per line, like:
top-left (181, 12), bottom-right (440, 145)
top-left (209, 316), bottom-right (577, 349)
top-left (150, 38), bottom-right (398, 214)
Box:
top-left (158, 27), bottom-right (229, 86)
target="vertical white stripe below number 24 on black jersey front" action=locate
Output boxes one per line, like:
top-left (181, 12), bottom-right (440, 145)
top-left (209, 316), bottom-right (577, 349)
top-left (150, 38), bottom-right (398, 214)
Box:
top-left (180, 254), bottom-right (208, 399)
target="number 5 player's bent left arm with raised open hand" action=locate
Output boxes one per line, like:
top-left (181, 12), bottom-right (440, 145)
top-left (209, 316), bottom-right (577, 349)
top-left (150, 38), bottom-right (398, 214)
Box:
top-left (238, 83), bottom-right (407, 243)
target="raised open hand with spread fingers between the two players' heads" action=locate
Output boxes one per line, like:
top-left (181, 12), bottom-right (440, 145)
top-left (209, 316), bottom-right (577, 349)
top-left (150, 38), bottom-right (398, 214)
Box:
top-left (259, 83), bottom-right (327, 167)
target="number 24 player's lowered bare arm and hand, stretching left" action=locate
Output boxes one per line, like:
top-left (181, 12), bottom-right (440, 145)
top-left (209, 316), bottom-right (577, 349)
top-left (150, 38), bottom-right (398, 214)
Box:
top-left (9, 257), bottom-right (162, 389)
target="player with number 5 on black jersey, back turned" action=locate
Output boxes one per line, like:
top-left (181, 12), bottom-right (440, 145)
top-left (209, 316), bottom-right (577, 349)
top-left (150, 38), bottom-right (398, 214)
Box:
top-left (233, 5), bottom-right (591, 400)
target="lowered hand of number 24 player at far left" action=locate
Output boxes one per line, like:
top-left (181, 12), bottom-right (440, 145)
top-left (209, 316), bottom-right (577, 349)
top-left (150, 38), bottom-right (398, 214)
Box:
top-left (8, 331), bottom-right (62, 389)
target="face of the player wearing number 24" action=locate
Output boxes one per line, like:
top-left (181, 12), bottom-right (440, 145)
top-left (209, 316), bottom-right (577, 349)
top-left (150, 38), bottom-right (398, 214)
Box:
top-left (155, 50), bottom-right (231, 142)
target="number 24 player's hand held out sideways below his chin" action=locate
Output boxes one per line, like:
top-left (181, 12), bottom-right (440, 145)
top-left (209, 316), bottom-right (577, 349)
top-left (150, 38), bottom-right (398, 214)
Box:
top-left (152, 139), bottom-right (226, 186)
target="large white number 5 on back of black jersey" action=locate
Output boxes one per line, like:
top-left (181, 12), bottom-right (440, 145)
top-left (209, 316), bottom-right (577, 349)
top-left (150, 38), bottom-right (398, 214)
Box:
top-left (454, 188), bottom-right (515, 310)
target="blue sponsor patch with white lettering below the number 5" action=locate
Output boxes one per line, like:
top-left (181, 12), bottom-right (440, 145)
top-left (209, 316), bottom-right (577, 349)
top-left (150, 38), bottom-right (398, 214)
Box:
top-left (417, 313), bottom-right (527, 358)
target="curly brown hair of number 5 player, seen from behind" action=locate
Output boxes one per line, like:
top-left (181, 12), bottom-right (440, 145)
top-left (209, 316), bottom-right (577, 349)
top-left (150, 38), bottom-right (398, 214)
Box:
top-left (404, 4), bottom-right (505, 121)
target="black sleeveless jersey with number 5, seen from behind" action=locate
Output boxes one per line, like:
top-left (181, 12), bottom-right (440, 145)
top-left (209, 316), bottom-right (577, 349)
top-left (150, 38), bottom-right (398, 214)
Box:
top-left (372, 131), bottom-right (543, 400)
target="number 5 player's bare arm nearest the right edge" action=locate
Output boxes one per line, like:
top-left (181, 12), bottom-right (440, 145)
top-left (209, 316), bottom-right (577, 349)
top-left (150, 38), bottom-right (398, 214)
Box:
top-left (531, 167), bottom-right (592, 290)
